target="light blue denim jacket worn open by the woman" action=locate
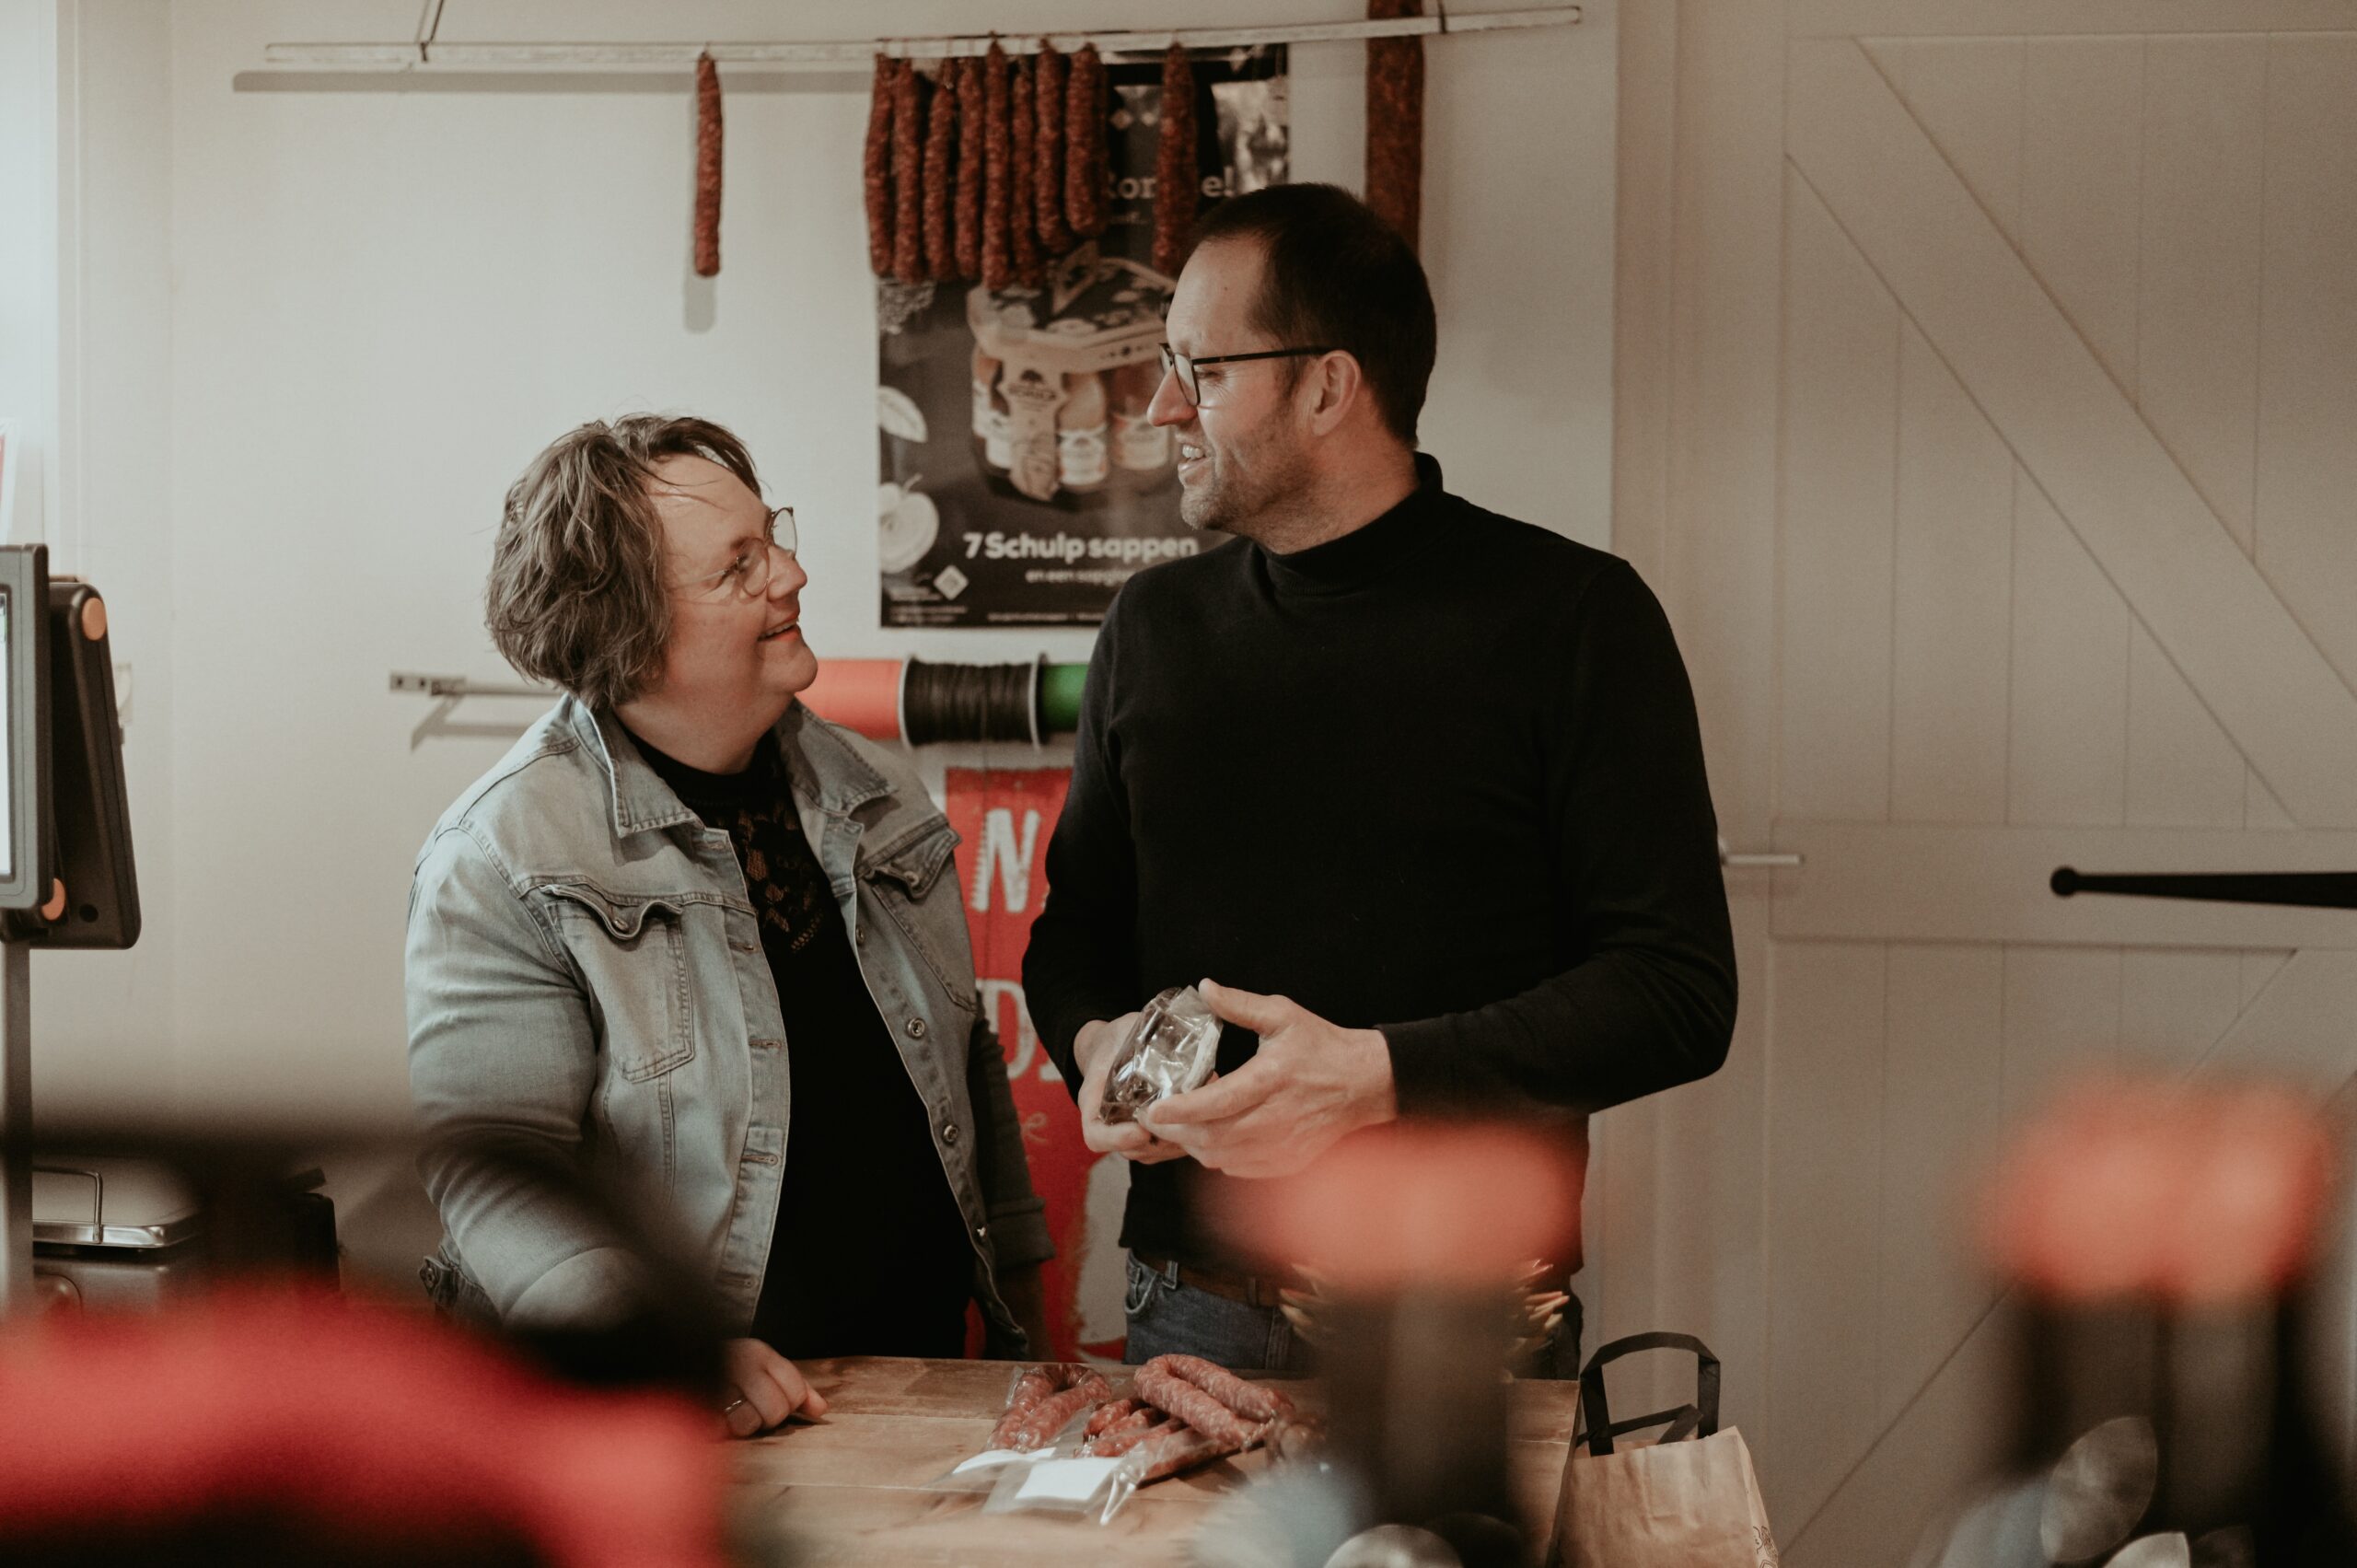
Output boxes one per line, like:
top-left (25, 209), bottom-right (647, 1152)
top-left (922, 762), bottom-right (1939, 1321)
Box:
top-left (408, 698), bottom-right (1053, 1349)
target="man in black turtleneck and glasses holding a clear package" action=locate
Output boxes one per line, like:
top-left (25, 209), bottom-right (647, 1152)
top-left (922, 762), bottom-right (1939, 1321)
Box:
top-left (1023, 186), bottom-right (1735, 1367)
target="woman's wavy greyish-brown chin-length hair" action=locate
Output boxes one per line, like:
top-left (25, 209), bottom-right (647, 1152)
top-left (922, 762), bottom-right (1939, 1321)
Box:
top-left (483, 412), bottom-right (761, 707)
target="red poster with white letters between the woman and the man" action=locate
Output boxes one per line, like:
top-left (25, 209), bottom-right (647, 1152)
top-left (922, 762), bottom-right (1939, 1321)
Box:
top-left (946, 769), bottom-right (1129, 1361)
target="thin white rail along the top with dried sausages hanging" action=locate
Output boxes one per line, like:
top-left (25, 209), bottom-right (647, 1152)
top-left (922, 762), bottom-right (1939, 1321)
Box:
top-left (261, 0), bottom-right (1582, 73)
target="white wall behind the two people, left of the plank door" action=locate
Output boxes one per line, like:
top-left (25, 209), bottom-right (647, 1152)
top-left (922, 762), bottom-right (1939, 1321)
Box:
top-left (32, 0), bottom-right (1615, 1136)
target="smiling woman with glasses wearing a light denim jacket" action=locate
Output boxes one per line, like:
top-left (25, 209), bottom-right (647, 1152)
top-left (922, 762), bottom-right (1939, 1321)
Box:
top-left (408, 415), bottom-right (1051, 1436)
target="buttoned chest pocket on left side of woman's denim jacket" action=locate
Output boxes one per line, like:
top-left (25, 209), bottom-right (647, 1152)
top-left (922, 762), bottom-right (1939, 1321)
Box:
top-left (544, 882), bottom-right (695, 1082)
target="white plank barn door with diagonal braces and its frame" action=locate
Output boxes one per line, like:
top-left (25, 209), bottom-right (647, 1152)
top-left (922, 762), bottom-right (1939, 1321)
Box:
top-left (1588, 0), bottom-right (2357, 1568)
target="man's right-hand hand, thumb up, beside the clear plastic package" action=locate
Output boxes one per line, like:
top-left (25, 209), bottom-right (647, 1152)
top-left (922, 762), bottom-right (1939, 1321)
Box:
top-left (1141, 981), bottom-right (1400, 1177)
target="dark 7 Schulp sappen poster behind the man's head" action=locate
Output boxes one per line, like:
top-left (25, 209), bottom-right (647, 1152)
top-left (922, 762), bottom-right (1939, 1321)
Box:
top-left (877, 45), bottom-right (1289, 627)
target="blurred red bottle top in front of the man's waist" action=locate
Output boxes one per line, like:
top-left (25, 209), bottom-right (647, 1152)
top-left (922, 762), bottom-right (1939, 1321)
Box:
top-left (1235, 1122), bottom-right (1579, 1292)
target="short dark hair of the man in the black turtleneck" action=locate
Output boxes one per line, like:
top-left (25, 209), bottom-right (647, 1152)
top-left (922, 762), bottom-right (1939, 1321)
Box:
top-left (1195, 184), bottom-right (1440, 446)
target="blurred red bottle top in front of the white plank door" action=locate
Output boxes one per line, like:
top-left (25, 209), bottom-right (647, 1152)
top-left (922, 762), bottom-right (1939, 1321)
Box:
top-left (1982, 1080), bottom-right (2333, 1307)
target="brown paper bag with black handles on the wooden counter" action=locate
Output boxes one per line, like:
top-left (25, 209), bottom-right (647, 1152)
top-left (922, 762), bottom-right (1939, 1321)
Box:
top-left (1549, 1334), bottom-right (1777, 1568)
